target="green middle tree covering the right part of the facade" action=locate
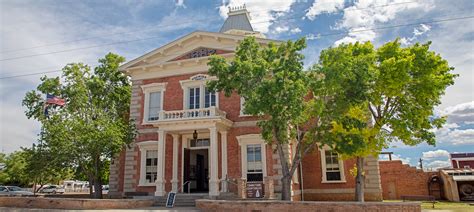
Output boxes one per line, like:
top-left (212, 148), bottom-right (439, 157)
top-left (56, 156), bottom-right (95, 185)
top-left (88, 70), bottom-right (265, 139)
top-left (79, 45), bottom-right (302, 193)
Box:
top-left (208, 37), bottom-right (315, 200)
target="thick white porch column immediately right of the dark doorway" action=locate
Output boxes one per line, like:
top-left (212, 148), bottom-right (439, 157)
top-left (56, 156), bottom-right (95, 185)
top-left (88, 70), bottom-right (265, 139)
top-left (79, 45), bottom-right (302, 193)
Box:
top-left (209, 127), bottom-right (219, 196)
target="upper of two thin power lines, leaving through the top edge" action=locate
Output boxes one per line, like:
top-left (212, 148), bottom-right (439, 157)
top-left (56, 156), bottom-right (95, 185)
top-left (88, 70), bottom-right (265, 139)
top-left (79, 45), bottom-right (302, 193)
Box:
top-left (0, 0), bottom-right (419, 54)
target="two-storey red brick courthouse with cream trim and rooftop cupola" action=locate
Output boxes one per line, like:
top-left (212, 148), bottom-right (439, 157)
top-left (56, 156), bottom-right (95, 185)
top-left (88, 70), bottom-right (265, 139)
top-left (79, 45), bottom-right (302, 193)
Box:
top-left (109, 7), bottom-right (382, 200)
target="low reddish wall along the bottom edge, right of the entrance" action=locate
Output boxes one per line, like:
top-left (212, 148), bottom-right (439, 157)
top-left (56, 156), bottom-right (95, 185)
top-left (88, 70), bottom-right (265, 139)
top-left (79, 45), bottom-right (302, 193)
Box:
top-left (196, 200), bottom-right (421, 212)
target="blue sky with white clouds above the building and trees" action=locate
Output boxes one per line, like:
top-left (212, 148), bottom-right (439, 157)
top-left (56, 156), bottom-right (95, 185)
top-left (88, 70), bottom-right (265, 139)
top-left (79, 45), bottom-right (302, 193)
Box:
top-left (0, 0), bottom-right (474, 168)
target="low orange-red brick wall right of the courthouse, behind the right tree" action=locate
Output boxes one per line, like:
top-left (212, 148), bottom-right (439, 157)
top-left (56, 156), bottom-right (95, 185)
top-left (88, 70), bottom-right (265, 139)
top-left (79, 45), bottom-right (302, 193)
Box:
top-left (379, 160), bottom-right (437, 199)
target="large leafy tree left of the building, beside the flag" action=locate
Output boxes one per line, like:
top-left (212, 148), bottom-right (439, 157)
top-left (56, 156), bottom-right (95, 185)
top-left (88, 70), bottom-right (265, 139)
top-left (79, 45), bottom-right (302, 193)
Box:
top-left (23, 53), bottom-right (135, 198)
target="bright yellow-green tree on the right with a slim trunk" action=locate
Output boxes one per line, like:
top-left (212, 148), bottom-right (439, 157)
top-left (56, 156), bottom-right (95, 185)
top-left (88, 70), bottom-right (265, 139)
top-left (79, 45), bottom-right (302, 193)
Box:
top-left (310, 39), bottom-right (456, 201)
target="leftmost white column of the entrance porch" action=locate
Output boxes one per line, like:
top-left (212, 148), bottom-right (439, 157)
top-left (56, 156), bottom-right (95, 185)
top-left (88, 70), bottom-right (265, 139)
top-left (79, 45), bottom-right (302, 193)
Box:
top-left (155, 130), bottom-right (166, 196)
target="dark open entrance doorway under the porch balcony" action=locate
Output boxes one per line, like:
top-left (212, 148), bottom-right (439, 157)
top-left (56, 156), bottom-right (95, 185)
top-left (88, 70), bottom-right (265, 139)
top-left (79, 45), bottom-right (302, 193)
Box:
top-left (183, 148), bottom-right (209, 193)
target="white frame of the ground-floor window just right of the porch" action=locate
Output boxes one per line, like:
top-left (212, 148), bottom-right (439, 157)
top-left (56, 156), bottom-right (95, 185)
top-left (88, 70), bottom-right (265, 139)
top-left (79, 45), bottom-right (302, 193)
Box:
top-left (237, 134), bottom-right (267, 179)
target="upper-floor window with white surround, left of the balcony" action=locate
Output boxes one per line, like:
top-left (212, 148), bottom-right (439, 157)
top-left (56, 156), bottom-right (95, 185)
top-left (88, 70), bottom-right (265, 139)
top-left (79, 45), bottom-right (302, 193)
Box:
top-left (141, 83), bottom-right (166, 123)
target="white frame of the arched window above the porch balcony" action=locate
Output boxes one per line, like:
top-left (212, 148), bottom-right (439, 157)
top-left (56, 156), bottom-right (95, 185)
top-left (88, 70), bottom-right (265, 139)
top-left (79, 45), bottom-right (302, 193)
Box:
top-left (179, 74), bottom-right (219, 110)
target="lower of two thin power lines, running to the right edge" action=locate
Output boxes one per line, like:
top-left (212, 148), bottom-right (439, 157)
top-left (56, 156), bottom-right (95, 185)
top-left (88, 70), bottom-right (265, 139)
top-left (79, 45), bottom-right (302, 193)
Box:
top-left (0, 16), bottom-right (474, 80)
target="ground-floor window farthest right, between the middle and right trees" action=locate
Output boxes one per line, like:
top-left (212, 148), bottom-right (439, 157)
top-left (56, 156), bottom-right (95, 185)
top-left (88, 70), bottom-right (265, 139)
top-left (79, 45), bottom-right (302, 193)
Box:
top-left (321, 148), bottom-right (345, 183)
